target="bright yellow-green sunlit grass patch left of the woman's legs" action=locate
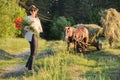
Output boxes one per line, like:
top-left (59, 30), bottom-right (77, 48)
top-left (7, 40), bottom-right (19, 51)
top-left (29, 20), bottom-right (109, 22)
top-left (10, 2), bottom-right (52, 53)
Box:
top-left (0, 38), bottom-right (29, 54)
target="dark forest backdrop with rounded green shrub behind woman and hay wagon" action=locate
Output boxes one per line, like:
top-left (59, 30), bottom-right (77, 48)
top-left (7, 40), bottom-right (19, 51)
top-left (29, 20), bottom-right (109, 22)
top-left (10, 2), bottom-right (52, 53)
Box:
top-left (0, 0), bottom-right (120, 39)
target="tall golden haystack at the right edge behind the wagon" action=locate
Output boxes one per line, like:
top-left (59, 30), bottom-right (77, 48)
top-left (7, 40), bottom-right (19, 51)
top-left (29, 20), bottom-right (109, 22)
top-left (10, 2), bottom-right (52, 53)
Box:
top-left (101, 8), bottom-right (120, 42)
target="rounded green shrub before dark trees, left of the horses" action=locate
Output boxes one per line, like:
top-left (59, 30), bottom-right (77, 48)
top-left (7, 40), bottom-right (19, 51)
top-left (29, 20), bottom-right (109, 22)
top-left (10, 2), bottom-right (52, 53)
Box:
top-left (50, 16), bottom-right (71, 40)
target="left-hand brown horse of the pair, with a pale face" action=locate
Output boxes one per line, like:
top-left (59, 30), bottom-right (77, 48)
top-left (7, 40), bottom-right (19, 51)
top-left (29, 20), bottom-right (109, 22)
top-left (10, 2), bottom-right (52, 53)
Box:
top-left (64, 26), bottom-right (76, 52)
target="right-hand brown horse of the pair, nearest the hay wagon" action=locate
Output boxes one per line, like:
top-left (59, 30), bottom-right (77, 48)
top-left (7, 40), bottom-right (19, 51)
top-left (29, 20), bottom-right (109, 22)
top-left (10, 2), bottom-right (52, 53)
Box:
top-left (73, 26), bottom-right (89, 53)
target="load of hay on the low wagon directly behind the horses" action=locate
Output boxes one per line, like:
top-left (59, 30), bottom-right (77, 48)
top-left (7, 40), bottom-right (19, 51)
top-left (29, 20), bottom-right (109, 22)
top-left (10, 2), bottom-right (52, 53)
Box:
top-left (73, 24), bottom-right (103, 43)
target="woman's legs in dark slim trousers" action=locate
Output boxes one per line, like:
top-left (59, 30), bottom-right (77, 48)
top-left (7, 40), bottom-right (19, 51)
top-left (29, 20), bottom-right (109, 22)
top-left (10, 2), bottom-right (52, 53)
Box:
top-left (26, 35), bottom-right (38, 70)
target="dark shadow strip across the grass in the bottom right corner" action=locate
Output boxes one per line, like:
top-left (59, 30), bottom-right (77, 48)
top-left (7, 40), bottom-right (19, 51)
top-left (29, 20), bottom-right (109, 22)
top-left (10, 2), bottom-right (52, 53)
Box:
top-left (79, 68), bottom-right (120, 80)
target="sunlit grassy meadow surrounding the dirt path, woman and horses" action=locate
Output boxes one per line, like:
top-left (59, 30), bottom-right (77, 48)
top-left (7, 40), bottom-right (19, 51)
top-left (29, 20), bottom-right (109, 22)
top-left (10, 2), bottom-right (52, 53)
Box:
top-left (0, 38), bottom-right (120, 80)
